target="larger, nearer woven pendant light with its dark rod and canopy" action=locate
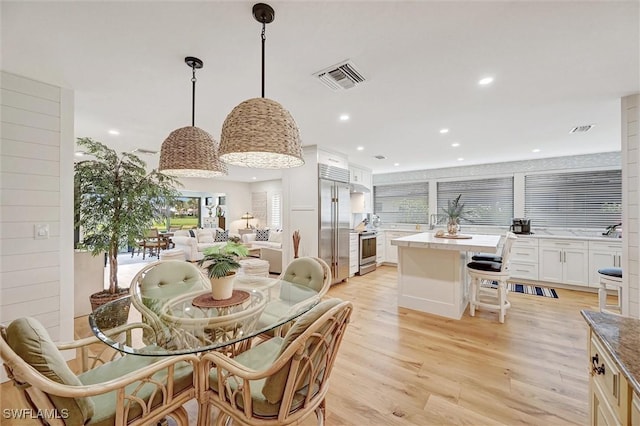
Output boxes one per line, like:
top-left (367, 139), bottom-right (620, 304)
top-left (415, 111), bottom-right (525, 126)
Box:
top-left (219, 3), bottom-right (304, 169)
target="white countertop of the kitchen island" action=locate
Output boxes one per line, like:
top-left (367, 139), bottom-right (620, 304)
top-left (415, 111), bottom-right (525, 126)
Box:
top-left (391, 232), bottom-right (500, 253)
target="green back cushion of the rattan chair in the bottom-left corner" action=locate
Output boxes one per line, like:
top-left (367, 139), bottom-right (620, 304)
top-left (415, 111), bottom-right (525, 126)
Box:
top-left (7, 317), bottom-right (95, 424)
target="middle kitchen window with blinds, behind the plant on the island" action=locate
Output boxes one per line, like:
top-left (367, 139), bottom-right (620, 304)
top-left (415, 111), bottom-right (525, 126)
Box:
top-left (438, 177), bottom-right (513, 226)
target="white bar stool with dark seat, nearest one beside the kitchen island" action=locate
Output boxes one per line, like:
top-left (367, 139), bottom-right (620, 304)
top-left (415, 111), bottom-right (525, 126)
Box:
top-left (467, 232), bottom-right (517, 323)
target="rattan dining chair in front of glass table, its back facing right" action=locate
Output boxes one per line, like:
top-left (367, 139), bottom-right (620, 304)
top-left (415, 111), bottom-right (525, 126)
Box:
top-left (198, 299), bottom-right (353, 426)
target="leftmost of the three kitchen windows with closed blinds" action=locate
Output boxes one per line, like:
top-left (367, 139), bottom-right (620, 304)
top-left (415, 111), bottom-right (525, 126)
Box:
top-left (373, 182), bottom-right (429, 223)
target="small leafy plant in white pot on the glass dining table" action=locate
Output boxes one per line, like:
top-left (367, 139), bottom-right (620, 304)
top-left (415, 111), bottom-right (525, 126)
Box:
top-left (198, 241), bottom-right (249, 300)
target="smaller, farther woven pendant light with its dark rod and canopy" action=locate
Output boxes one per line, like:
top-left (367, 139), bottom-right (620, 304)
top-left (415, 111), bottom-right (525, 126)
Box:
top-left (159, 56), bottom-right (227, 178)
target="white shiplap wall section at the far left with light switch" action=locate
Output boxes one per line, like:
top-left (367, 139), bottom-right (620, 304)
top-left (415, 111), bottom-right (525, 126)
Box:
top-left (0, 72), bottom-right (74, 340)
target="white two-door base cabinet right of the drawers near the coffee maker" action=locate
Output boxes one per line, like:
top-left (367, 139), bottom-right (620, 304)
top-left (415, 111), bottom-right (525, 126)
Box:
top-left (538, 239), bottom-right (589, 286)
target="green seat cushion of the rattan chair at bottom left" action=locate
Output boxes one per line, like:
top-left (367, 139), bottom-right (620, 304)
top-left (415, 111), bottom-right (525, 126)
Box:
top-left (78, 355), bottom-right (193, 426)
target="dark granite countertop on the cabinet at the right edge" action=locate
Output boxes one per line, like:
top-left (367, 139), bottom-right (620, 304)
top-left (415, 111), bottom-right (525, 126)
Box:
top-left (581, 311), bottom-right (640, 395)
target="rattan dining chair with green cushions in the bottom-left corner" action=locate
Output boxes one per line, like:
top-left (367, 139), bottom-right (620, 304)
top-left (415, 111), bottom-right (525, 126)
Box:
top-left (0, 317), bottom-right (198, 426)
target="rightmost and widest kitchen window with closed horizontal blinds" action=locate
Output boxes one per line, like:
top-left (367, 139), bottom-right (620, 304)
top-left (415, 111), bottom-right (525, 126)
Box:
top-left (524, 170), bottom-right (622, 228)
